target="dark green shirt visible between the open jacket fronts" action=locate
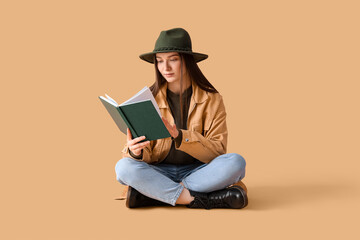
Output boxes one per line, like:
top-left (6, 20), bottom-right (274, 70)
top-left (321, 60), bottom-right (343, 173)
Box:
top-left (161, 86), bottom-right (198, 165)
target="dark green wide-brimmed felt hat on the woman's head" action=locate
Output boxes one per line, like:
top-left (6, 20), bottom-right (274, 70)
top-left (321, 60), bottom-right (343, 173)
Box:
top-left (139, 28), bottom-right (208, 63)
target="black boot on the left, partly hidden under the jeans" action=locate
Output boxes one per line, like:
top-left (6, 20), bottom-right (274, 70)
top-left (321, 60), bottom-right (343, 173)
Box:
top-left (126, 186), bottom-right (172, 208)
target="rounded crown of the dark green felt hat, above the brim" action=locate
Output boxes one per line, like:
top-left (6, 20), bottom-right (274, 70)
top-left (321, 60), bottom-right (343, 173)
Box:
top-left (154, 28), bottom-right (192, 51)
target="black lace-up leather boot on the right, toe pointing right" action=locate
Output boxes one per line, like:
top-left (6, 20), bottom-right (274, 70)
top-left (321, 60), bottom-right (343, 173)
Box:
top-left (187, 186), bottom-right (248, 209)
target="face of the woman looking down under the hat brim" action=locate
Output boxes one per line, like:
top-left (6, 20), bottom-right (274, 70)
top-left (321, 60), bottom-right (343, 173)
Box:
top-left (156, 52), bottom-right (186, 83)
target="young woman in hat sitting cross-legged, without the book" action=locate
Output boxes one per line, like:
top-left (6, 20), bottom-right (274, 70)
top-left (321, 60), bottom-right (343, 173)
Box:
top-left (115, 28), bottom-right (248, 209)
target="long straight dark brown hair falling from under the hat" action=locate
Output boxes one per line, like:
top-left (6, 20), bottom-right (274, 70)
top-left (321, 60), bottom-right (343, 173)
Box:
top-left (150, 52), bottom-right (218, 126)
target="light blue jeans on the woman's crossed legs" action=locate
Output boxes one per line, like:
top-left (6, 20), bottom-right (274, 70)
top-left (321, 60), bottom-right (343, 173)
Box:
top-left (115, 153), bottom-right (246, 206)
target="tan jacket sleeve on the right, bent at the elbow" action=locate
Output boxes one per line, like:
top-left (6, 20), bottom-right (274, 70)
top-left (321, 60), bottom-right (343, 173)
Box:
top-left (176, 97), bottom-right (228, 163)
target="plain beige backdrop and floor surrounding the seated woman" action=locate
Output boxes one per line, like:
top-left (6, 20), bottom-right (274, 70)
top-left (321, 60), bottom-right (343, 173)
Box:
top-left (0, 1), bottom-right (360, 240)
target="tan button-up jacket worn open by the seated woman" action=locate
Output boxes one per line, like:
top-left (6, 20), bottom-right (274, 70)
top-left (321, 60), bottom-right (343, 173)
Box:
top-left (123, 82), bottom-right (228, 163)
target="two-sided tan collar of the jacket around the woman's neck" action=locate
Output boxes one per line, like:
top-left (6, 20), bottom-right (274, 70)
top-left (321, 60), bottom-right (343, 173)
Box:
top-left (155, 81), bottom-right (208, 108)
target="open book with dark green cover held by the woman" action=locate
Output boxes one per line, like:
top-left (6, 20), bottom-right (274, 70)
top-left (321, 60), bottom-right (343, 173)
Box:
top-left (99, 87), bottom-right (171, 141)
